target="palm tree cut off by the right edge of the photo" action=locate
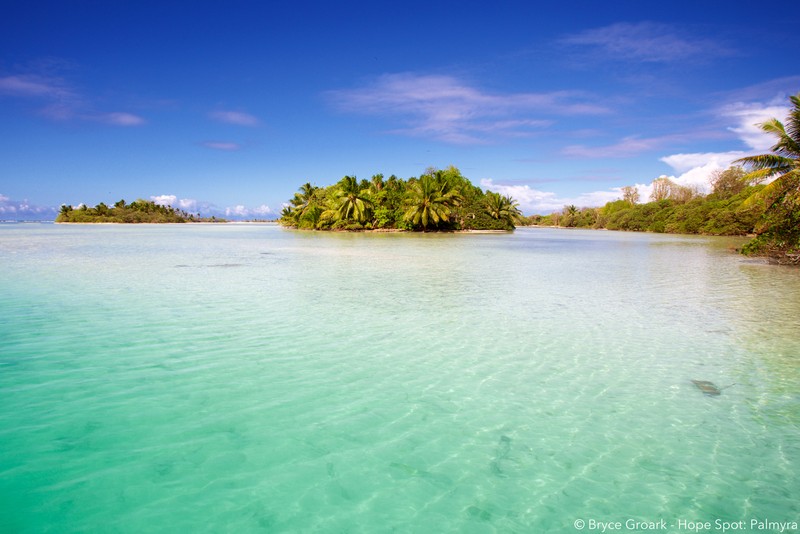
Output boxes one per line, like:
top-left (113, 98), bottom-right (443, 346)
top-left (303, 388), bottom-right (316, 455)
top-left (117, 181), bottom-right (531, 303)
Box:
top-left (734, 93), bottom-right (800, 255)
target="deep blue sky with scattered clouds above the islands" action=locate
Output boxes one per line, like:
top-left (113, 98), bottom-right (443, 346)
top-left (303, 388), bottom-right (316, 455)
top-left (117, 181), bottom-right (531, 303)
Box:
top-left (0, 0), bottom-right (800, 219)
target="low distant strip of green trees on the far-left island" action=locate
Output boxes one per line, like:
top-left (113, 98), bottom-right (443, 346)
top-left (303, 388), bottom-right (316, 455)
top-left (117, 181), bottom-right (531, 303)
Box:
top-left (56, 199), bottom-right (225, 223)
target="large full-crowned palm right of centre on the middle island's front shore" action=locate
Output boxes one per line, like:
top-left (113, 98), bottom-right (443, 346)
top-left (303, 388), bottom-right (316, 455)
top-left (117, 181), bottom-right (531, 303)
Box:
top-left (403, 171), bottom-right (461, 230)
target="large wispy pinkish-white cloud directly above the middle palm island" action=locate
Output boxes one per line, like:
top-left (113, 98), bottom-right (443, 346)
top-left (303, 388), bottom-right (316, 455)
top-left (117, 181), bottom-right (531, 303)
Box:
top-left (327, 73), bottom-right (609, 144)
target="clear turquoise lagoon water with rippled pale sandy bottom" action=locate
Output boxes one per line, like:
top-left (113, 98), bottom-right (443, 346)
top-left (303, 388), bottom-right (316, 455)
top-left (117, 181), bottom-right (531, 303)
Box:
top-left (0, 225), bottom-right (800, 533)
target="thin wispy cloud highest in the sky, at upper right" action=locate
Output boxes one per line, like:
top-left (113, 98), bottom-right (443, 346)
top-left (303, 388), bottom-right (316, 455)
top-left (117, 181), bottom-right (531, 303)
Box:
top-left (561, 22), bottom-right (731, 63)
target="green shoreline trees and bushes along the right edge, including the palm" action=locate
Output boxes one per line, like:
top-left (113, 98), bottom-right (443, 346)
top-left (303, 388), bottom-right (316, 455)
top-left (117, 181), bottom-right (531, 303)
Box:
top-left (525, 93), bottom-right (800, 264)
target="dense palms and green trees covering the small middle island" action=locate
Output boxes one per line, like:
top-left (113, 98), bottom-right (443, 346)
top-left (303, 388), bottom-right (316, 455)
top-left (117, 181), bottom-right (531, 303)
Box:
top-left (280, 166), bottom-right (522, 232)
